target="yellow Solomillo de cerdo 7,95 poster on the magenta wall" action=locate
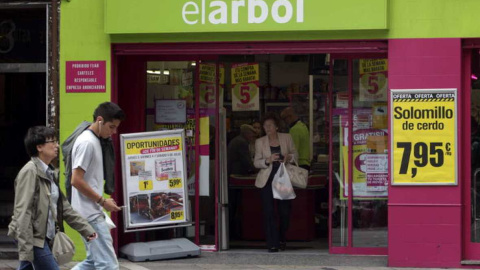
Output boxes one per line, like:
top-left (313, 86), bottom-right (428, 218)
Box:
top-left (390, 89), bottom-right (457, 185)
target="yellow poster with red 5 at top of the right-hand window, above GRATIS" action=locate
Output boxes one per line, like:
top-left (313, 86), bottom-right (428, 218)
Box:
top-left (359, 59), bottom-right (388, 101)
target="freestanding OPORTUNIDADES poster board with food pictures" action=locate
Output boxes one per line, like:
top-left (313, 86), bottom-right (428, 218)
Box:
top-left (121, 129), bottom-right (188, 231)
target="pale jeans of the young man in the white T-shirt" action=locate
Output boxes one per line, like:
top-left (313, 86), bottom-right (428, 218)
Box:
top-left (72, 215), bottom-right (120, 270)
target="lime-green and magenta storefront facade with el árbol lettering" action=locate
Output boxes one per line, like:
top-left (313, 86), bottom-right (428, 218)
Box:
top-left (59, 0), bottom-right (480, 267)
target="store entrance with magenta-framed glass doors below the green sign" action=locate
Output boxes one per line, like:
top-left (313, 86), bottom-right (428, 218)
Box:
top-left (114, 41), bottom-right (388, 254)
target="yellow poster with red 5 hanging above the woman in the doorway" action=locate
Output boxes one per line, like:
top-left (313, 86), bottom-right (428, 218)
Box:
top-left (232, 63), bottom-right (260, 111)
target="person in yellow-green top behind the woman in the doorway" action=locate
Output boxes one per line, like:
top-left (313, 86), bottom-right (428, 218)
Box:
top-left (280, 107), bottom-right (310, 171)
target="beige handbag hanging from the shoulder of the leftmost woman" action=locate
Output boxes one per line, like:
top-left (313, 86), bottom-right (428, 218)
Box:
top-left (44, 178), bottom-right (75, 265)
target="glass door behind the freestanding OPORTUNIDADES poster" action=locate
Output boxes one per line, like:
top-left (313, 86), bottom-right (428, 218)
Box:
top-left (141, 57), bottom-right (221, 250)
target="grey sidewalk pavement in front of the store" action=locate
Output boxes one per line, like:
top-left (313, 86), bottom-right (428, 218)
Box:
top-left (0, 250), bottom-right (464, 270)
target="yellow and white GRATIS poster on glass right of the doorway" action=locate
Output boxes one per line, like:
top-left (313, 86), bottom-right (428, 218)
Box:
top-left (340, 109), bottom-right (388, 199)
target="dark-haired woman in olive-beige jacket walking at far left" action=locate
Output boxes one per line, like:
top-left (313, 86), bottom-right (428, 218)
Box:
top-left (8, 126), bottom-right (97, 269)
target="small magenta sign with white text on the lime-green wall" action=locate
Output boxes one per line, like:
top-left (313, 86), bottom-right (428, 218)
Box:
top-left (65, 61), bottom-right (106, 93)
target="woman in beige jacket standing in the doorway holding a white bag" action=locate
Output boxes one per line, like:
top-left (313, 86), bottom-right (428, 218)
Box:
top-left (254, 113), bottom-right (298, 252)
